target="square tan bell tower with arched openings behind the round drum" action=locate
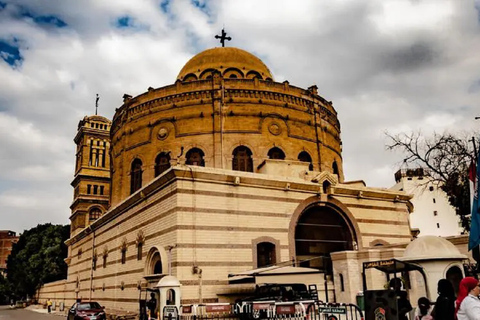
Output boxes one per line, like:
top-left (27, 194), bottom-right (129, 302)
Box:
top-left (70, 115), bottom-right (112, 236)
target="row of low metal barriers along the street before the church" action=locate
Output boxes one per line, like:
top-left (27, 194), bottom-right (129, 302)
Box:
top-left (177, 300), bottom-right (364, 320)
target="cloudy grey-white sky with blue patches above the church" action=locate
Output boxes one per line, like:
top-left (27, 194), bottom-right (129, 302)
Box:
top-left (0, 0), bottom-right (480, 232)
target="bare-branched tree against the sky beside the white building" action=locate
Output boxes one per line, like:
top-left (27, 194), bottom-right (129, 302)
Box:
top-left (386, 132), bottom-right (478, 231)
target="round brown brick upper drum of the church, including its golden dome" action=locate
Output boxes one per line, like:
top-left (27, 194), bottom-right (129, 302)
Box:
top-left (111, 48), bottom-right (343, 205)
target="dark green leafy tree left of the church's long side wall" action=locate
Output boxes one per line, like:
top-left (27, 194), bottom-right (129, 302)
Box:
top-left (7, 223), bottom-right (70, 298)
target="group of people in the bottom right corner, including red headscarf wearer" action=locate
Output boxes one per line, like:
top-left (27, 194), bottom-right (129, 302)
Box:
top-left (406, 277), bottom-right (480, 320)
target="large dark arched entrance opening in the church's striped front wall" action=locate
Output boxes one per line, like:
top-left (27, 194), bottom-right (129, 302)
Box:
top-left (295, 204), bottom-right (356, 274)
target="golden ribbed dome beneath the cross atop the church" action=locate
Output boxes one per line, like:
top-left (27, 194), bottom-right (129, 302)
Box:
top-left (177, 47), bottom-right (273, 81)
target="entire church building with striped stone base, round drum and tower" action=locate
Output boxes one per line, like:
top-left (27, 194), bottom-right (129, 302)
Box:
top-left (37, 43), bottom-right (412, 311)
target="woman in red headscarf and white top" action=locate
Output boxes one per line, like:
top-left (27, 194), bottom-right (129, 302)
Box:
top-left (455, 277), bottom-right (480, 320)
